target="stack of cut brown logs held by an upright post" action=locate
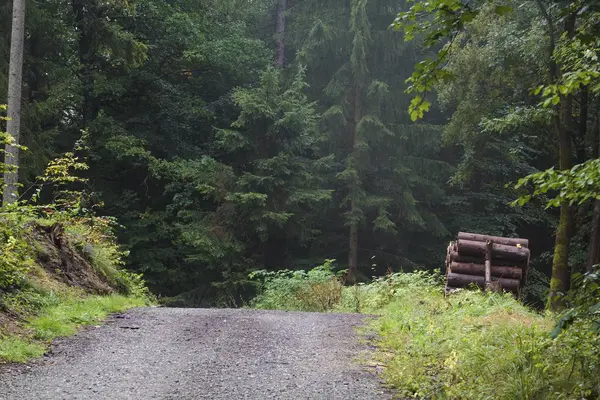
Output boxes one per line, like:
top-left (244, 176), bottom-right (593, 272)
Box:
top-left (446, 232), bottom-right (529, 297)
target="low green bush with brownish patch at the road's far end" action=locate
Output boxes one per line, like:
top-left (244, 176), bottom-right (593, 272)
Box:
top-left (250, 260), bottom-right (343, 312)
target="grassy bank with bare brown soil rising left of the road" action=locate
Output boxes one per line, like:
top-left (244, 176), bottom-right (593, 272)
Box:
top-left (0, 216), bottom-right (150, 363)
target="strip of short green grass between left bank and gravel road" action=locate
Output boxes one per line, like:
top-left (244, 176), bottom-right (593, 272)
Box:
top-left (0, 295), bottom-right (147, 362)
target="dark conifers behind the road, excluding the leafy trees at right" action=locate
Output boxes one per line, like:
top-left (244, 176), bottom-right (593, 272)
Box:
top-left (0, 0), bottom-right (455, 304)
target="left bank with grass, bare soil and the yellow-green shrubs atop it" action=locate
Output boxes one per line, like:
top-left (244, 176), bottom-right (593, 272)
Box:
top-left (0, 117), bottom-right (151, 363)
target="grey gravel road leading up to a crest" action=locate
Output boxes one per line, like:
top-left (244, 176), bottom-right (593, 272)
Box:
top-left (0, 308), bottom-right (390, 400)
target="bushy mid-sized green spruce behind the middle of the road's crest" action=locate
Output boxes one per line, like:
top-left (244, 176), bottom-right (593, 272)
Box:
top-left (216, 68), bottom-right (331, 268)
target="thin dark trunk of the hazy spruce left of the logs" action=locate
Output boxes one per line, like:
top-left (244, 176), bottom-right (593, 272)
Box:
top-left (348, 85), bottom-right (363, 283)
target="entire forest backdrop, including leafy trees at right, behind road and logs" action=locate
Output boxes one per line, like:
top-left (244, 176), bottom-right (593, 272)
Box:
top-left (0, 0), bottom-right (600, 318)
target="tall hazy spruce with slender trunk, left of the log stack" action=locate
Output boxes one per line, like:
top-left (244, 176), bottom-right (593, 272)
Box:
top-left (296, 0), bottom-right (448, 281)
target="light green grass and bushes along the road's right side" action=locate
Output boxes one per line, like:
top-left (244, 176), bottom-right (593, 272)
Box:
top-left (253, 262), bottom-right (600, 400)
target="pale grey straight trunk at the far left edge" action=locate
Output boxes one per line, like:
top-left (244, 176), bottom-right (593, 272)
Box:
top-left (2, 0), bottom-right (25, 204)
